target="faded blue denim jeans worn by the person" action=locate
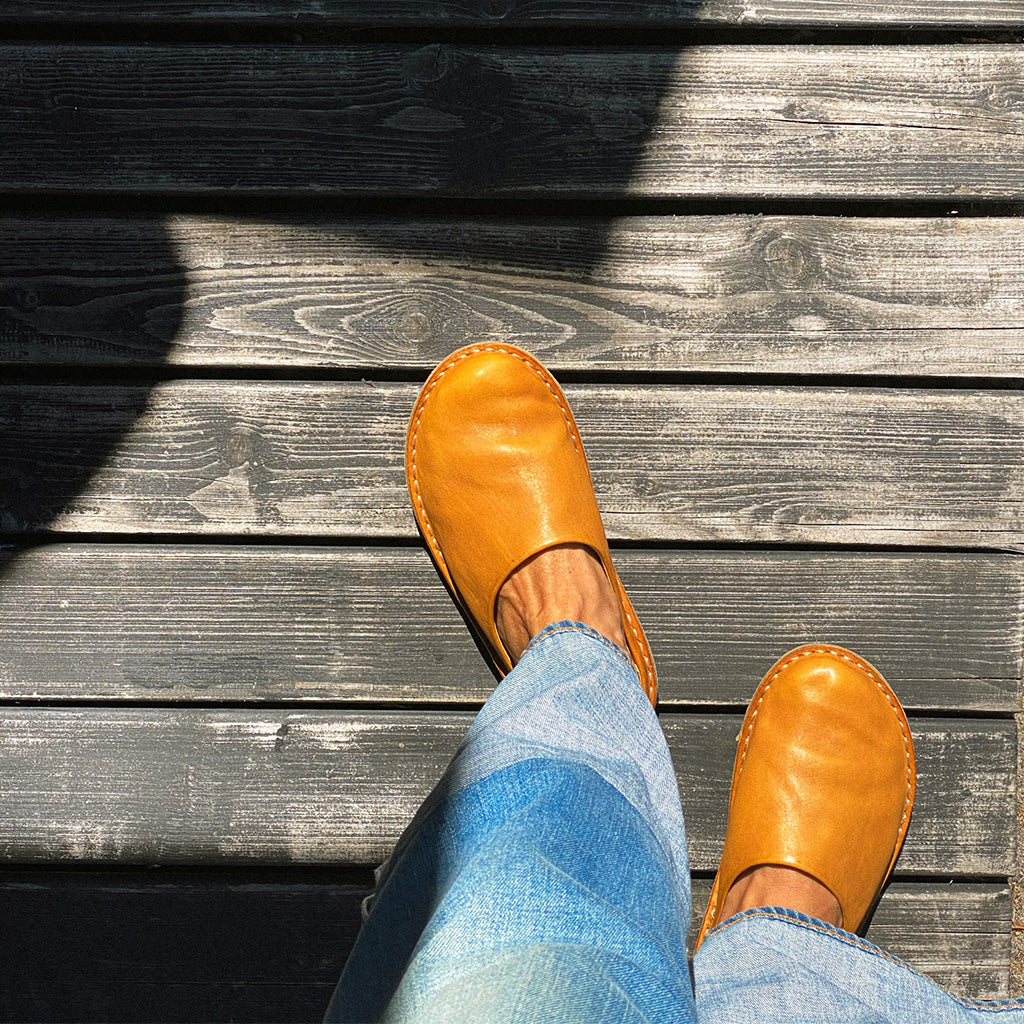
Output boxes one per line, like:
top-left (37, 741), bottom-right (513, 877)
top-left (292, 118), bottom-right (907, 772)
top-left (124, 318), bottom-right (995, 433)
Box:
top-left (327, 623), bottom-right (1024, 1024)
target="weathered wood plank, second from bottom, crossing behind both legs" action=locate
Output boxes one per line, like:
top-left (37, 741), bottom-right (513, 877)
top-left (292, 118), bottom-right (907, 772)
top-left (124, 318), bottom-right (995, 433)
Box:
top-left (0, 708), bottom-right (1017, 878)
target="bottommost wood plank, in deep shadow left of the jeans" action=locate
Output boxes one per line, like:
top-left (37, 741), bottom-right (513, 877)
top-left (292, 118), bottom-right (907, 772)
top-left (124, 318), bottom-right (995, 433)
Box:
top-left (0, 869), bottom-right (1010, 1024)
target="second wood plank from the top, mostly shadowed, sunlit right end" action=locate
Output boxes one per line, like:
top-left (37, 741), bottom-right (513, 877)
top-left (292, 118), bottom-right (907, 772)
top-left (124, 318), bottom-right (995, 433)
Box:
top-left (0, 45), bottom-right (1024, 201)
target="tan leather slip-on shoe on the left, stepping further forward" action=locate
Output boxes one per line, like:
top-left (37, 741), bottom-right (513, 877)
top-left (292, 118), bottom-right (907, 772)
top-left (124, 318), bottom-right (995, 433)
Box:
top-left (406, 343), bottom-right (657, 703)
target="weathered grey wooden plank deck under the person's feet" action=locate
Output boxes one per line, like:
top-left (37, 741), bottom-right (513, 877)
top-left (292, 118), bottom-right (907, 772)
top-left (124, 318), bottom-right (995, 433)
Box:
top-left (0, 0), bottom-right (1024, 1021)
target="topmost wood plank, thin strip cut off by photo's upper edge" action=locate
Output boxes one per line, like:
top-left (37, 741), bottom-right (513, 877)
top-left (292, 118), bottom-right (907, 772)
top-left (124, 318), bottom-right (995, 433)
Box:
top-left (3, 0), bottom-right (1022, 29)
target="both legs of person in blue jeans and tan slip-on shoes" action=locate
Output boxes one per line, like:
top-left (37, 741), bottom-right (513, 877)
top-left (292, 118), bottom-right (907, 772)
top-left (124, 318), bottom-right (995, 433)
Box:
top-left (329, 344), bottom-right (1024, 1024)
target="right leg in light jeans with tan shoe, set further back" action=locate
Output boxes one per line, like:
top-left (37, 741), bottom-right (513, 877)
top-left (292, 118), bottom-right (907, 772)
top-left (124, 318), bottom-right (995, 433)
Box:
top-left (693, 644), bottom-right (1024, 1024)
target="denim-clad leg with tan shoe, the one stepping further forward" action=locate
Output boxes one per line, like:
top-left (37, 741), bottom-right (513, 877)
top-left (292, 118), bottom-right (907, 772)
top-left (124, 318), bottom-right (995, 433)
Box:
top-left (329, 344), bottom-right (693, 1024)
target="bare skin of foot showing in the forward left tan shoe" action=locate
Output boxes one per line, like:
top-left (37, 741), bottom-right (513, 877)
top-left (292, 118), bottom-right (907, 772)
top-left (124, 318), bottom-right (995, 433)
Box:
top-left (495, 544), bottom-right (626, 665)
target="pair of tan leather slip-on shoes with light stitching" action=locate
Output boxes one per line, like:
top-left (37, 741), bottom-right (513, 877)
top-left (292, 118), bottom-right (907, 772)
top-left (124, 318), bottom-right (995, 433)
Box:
top-left (406, 343), bottom-right (915, 945)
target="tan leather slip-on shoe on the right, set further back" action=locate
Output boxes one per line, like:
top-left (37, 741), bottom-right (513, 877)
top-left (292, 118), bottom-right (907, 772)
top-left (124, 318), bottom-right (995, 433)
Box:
top-left (696, 644), bottom-right (916, 946)
